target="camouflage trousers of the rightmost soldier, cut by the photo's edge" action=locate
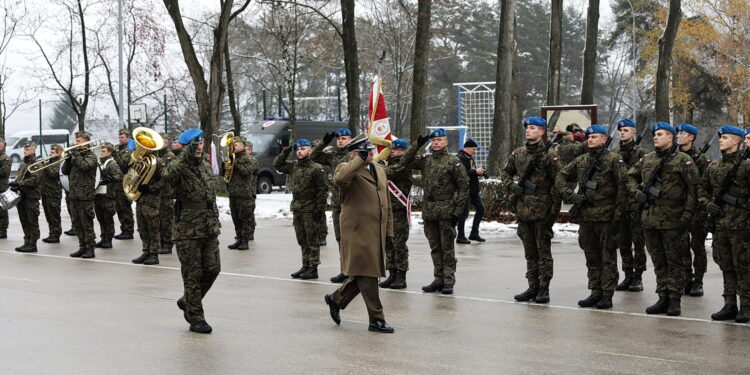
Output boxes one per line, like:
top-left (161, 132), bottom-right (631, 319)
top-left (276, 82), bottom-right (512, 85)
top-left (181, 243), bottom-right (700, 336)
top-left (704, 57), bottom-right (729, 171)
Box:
top-left (712, 230), bottom-right (750, 306)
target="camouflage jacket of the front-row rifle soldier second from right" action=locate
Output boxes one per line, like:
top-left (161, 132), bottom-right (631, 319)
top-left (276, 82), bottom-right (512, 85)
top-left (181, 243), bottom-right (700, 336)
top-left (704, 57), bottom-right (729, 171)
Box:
top-left (628, 150), bottom-right (698, 229)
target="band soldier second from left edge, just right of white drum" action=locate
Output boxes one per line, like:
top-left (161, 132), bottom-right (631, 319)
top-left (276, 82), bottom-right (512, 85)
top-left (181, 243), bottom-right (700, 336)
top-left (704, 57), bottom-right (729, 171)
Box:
top-left (8, 141), bottom-right (42, 253)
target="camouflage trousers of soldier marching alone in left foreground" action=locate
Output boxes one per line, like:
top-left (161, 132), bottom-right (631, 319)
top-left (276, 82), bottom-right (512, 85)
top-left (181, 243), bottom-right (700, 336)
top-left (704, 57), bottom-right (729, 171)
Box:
top-left (175, 235), bottom-right (221, 323)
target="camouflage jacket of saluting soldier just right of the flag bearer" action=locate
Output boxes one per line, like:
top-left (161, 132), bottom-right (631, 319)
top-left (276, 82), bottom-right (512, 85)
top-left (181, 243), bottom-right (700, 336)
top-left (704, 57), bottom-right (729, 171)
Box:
top-left (399, 143), bottom-right (469, 221)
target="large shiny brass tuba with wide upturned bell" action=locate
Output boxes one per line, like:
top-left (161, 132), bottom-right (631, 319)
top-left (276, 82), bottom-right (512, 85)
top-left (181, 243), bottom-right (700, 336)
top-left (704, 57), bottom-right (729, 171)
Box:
top-left (122, 127), bottom-right (165, 201)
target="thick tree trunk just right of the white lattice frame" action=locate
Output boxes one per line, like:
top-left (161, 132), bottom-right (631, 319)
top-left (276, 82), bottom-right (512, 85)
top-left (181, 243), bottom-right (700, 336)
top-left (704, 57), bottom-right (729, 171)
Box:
top-left (489, 0), bottom-right (516, 176)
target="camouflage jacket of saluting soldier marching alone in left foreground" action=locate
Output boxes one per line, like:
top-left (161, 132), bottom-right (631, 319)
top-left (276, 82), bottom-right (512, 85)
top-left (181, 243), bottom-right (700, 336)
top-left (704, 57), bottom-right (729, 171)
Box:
top-left (160, 152), bottom-right (221, 241)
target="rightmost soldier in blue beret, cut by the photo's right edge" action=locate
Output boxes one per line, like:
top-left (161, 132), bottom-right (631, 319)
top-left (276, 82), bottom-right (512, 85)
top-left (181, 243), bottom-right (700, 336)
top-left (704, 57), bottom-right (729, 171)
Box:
top-left (699, 125), bottom-right (750, 323)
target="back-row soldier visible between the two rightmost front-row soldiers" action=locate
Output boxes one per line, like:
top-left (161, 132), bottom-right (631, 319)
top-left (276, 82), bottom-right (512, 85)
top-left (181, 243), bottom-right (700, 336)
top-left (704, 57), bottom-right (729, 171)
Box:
top-left (676, 124), bottom-right (711, 297)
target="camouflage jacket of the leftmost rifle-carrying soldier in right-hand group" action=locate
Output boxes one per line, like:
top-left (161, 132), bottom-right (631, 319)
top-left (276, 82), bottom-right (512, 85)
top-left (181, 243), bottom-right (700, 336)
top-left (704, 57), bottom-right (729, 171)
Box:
top-left (500, 142), bottom-right (562, 221)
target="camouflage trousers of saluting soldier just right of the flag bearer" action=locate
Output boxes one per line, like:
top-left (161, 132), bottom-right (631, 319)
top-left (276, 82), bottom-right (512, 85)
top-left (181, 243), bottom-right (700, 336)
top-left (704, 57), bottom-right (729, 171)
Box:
top-left (424, 220), bottom-right (456, 285)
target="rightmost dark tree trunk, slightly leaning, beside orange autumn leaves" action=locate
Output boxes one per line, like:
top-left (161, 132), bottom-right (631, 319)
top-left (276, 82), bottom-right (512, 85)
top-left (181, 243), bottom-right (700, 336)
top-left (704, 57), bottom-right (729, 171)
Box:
top-left (654, 0), bottom-right (682, 122)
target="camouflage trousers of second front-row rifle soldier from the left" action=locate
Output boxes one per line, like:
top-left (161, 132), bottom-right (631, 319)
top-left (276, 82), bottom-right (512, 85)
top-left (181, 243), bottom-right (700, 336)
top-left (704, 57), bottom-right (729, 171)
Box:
top-left (578, 221), bottom-right (618, 296)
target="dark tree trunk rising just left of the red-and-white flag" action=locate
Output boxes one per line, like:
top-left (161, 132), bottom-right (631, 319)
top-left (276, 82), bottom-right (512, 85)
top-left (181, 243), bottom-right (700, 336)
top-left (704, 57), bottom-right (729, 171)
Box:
top-left (341, 0), bottom-right (360, 134)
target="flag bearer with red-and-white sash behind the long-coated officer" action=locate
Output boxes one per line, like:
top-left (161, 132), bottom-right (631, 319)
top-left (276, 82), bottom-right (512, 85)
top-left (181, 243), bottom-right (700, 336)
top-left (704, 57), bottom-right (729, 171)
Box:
top-left (380, 139), bottom-right (412, 289)
